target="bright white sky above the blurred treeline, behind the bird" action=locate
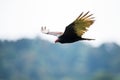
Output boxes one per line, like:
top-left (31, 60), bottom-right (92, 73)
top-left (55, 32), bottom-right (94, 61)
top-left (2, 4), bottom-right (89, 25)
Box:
top-left (0, 0), bottom-right (120, 44)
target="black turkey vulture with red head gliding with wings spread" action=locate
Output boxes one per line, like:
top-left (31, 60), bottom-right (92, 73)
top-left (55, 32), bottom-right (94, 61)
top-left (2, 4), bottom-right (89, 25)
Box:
top-left (41, 11), bottom-right (94, 43)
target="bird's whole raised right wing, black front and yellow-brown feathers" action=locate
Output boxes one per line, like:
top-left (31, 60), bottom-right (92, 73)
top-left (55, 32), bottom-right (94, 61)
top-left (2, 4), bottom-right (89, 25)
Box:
top-left (63, 11), bottom-right (94, 37)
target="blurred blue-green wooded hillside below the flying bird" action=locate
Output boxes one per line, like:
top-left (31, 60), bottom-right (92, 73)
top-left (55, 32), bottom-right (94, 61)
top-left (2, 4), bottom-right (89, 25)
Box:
top-left (0, 38), bottom-right (120, 80)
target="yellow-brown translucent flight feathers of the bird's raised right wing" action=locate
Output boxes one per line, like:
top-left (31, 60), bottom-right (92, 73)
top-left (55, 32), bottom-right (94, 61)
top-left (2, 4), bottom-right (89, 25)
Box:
top-left (74, 11), bottom-right (94, 37)
